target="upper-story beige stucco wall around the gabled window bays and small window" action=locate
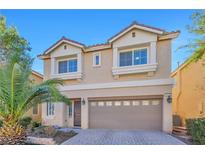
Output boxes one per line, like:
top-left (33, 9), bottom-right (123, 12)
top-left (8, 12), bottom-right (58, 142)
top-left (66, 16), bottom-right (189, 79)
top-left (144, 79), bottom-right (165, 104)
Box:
top-left (44, 40), bottom-right (171, 85)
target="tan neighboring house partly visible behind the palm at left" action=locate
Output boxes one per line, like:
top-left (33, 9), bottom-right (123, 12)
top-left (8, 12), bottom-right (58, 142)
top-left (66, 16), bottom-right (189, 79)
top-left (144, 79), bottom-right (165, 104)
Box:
top-left (25, 70), bottom-right (43, 122)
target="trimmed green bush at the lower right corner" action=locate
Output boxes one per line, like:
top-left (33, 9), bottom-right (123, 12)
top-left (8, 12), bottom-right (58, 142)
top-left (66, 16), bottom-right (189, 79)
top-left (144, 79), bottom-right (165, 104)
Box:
top-left (186, 118), bottom-right (205, 144)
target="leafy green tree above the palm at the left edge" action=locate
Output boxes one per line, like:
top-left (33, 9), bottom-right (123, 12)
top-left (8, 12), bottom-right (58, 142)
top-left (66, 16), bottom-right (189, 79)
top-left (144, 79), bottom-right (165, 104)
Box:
top-left (0, 16), bottom-right (33, 66)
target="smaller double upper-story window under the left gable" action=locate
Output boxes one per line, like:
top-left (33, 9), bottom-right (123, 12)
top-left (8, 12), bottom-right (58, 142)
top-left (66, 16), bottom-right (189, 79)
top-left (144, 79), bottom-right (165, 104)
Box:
top-left (58, 59), bottom-right (77, 74)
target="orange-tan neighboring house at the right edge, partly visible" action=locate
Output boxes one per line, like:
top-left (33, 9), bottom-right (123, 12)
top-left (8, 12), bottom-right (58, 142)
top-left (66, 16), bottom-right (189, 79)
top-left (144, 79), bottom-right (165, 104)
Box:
top-left (171, 60), bottom-right (205, 126)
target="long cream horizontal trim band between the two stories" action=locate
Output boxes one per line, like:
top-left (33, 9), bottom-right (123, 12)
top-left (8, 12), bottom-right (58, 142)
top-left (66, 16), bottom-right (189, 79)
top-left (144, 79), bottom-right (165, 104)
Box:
top-left (60, 78), bottom-right (174, 91)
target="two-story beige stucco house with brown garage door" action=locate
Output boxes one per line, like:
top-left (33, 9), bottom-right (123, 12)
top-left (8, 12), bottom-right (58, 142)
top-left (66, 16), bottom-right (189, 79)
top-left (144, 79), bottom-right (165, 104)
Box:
top-left (39, 22), bottom-right (179, 132)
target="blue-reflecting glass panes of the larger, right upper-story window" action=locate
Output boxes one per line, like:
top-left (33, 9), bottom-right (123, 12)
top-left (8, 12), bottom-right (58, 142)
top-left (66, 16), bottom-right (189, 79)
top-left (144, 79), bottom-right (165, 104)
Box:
top-left (119, 48), bottom-right (148, 67)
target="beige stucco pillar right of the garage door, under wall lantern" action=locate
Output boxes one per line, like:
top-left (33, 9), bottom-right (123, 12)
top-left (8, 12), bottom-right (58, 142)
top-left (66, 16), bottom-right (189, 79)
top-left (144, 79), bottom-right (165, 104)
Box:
top-left (162, 93), bottom-right (172, 133)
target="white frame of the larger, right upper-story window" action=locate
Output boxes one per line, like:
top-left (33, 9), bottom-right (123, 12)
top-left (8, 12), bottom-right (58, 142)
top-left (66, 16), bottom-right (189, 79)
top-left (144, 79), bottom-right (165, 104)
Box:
top-left (118, 47), bottom-right (150, 68)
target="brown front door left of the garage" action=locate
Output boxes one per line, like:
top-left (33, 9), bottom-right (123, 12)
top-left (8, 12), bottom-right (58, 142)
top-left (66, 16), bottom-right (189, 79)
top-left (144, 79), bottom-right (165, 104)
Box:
top-left (74, 100), bottom-right (81, 127)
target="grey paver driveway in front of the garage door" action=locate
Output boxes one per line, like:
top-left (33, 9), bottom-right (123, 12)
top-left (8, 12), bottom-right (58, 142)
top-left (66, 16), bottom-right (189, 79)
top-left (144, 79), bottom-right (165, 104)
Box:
top-left (63, 129), bottom-right (185, 145)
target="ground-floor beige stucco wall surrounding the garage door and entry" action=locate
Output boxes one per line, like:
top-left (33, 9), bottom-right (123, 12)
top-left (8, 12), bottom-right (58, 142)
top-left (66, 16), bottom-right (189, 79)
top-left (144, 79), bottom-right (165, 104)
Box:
top-left (43, 86), bottom-right (172, 132)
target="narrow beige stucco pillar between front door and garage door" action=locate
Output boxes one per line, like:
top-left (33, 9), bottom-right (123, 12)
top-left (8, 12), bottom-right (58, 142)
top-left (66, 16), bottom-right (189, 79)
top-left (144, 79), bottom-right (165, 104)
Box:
top-left (81, 97), bottom-right (89, 129)
